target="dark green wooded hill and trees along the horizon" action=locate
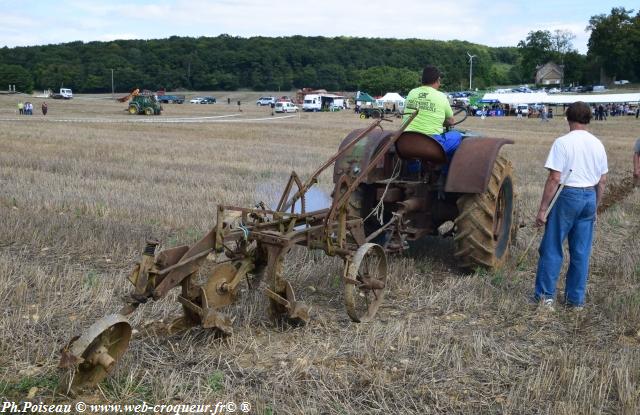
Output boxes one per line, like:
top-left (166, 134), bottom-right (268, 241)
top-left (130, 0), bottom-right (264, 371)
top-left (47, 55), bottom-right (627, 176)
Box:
top-left (0, 8), bottom-right (640, 94)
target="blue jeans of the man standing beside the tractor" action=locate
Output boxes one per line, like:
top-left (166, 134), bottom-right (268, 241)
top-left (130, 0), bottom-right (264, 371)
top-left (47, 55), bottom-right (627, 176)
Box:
top-left (535, 187), bottom-right (596, 306)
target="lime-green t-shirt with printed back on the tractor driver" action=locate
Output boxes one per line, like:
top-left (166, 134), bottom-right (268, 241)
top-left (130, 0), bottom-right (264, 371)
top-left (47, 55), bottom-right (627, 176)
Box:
top-left (404, 85), bottom-right (453, 135)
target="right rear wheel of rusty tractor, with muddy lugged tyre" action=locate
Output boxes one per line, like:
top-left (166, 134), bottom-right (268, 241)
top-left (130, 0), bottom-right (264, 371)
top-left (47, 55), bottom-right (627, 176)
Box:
top-left (454, 157), bottom-right (515, 270)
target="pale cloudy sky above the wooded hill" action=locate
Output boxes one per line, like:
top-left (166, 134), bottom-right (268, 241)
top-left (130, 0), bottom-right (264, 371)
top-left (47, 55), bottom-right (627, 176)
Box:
top-left (0, 0), bottom-right (640, 53)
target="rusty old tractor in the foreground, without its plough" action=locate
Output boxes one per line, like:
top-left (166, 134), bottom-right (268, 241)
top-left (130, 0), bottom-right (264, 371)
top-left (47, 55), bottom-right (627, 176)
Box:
top-left (333, 108), bottom-right (516, 269)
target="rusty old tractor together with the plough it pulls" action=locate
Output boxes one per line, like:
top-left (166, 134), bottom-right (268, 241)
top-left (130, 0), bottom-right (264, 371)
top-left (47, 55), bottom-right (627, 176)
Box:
top-left (59, 107), bottom-right (515, 393)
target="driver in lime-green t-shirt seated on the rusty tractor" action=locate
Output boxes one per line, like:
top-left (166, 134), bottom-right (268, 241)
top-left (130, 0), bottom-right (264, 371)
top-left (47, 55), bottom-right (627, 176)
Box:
top-left (396, 65), bottom-right (462, 170)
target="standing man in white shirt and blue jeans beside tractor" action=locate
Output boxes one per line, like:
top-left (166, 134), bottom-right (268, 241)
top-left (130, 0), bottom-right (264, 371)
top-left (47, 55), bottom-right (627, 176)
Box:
top-left (534, 101), bottom-right (608, 310)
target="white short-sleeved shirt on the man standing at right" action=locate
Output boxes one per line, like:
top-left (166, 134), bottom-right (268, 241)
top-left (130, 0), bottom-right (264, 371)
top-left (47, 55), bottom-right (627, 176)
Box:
top-left (544, 130), bottom-right (609, 187)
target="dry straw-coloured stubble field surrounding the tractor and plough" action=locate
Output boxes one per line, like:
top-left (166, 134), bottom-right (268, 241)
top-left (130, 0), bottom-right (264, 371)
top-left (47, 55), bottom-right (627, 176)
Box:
top-left (0, 93), bottom-right (640, 414)
